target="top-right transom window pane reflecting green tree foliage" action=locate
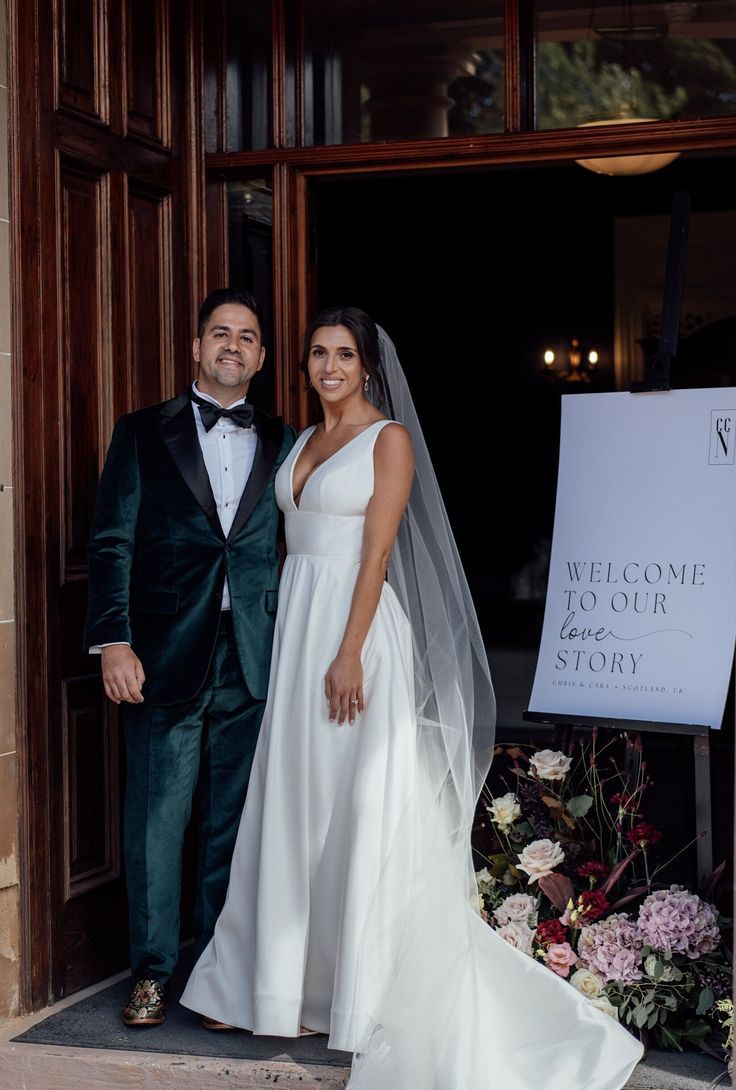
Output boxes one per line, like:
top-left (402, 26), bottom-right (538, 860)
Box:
top-left (536, 0), bottom-right (736, 129)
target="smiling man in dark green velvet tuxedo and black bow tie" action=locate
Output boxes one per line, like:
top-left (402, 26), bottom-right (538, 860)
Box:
top-left (85, 289), bottom-right (294, 1026)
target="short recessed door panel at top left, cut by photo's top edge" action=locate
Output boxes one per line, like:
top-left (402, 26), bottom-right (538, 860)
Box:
top-left (55, 0), bottom-right (108, 121)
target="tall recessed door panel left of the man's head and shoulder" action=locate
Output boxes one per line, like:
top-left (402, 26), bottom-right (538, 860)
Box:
top-left (57, 160), bottom-right (110, 582)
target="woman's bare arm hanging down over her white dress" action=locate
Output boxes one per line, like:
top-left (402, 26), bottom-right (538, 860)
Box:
top-left (325, 424), bottom-right (414, 725)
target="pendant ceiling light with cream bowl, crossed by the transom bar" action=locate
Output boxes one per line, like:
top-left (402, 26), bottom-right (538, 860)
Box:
top-left (576, 0), bottom-right (680, 177)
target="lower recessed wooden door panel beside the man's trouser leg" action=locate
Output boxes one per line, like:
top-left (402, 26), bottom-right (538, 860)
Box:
top-left (62, 674), bottom-right (120, 901)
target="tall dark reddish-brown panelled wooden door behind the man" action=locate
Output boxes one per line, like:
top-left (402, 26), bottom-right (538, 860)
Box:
top-left (10, 0), bottom-right (201, 1007)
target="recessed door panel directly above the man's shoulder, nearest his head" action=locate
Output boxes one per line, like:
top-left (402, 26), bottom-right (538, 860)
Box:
top-left (128, 187), bottom-right (173, 408)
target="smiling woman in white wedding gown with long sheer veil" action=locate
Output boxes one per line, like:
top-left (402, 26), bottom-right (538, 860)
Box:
top-left (181, 307), bottom-right (641, 1090)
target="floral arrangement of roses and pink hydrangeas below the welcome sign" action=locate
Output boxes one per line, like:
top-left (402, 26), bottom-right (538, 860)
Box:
top-left (475, 730), bottom-right (731, 1049)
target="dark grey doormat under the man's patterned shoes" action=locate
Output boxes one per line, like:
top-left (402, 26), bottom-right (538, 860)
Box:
top-left (13, 949), bottom-right (352, 1067)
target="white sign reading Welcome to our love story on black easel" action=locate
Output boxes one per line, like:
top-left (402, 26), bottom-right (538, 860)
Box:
top-left (530, 388), bottom-right (736, 728)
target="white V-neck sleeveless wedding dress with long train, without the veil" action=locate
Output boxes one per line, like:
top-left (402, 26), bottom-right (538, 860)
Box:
top-left (181, 421), bottom-right (641, 1090)
